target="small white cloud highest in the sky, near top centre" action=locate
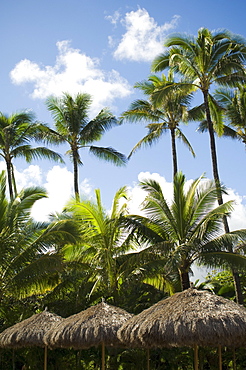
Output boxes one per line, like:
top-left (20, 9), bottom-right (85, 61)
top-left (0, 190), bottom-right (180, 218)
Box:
top-left (109, 9), bottom-right (179, 62)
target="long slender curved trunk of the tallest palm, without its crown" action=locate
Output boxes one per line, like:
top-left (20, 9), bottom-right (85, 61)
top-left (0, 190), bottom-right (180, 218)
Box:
top-left (203, 90), bottom-right (243, 304)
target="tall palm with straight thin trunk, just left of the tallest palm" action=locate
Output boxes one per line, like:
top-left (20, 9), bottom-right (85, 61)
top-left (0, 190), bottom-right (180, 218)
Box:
top-left (120, 75), bottom-right (195, 176)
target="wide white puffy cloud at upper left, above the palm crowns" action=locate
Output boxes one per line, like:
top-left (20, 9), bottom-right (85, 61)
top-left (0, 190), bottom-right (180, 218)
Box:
top-left (10, 40), bottom-right (132, 113)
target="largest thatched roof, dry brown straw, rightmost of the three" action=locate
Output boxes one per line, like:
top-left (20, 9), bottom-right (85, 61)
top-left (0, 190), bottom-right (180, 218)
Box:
top-left (117, 288), bottom-right (246, 348)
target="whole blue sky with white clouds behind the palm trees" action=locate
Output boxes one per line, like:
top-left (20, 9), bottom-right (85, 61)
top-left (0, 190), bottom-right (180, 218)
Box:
top-left (0, 0), bottom-right (246, 240)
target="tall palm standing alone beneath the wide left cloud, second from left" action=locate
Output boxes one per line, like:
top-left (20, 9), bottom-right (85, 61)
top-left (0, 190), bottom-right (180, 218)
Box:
top-left (46, 93), bottom-right (126, 197)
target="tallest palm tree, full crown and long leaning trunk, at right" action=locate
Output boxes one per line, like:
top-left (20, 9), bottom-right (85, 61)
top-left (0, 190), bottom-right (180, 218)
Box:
top-left (152, 28), bottom-right (246, 217)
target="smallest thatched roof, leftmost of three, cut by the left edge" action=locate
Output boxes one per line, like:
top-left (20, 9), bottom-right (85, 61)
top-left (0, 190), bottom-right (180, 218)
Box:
top-left (0, 310), bottom-right (63, 348)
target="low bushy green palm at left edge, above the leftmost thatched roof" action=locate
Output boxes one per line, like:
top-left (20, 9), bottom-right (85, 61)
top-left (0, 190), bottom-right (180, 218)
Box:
top-left (0, 171), bottom-right (76, 301)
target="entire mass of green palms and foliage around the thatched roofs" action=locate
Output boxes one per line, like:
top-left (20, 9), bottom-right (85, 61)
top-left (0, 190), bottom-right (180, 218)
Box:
top-left (0, 28), bottom-right (246, 370)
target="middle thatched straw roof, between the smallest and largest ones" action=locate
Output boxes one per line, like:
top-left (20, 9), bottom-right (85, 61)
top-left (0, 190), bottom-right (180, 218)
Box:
top-left (44, 302), bottom-right (132, 349)
